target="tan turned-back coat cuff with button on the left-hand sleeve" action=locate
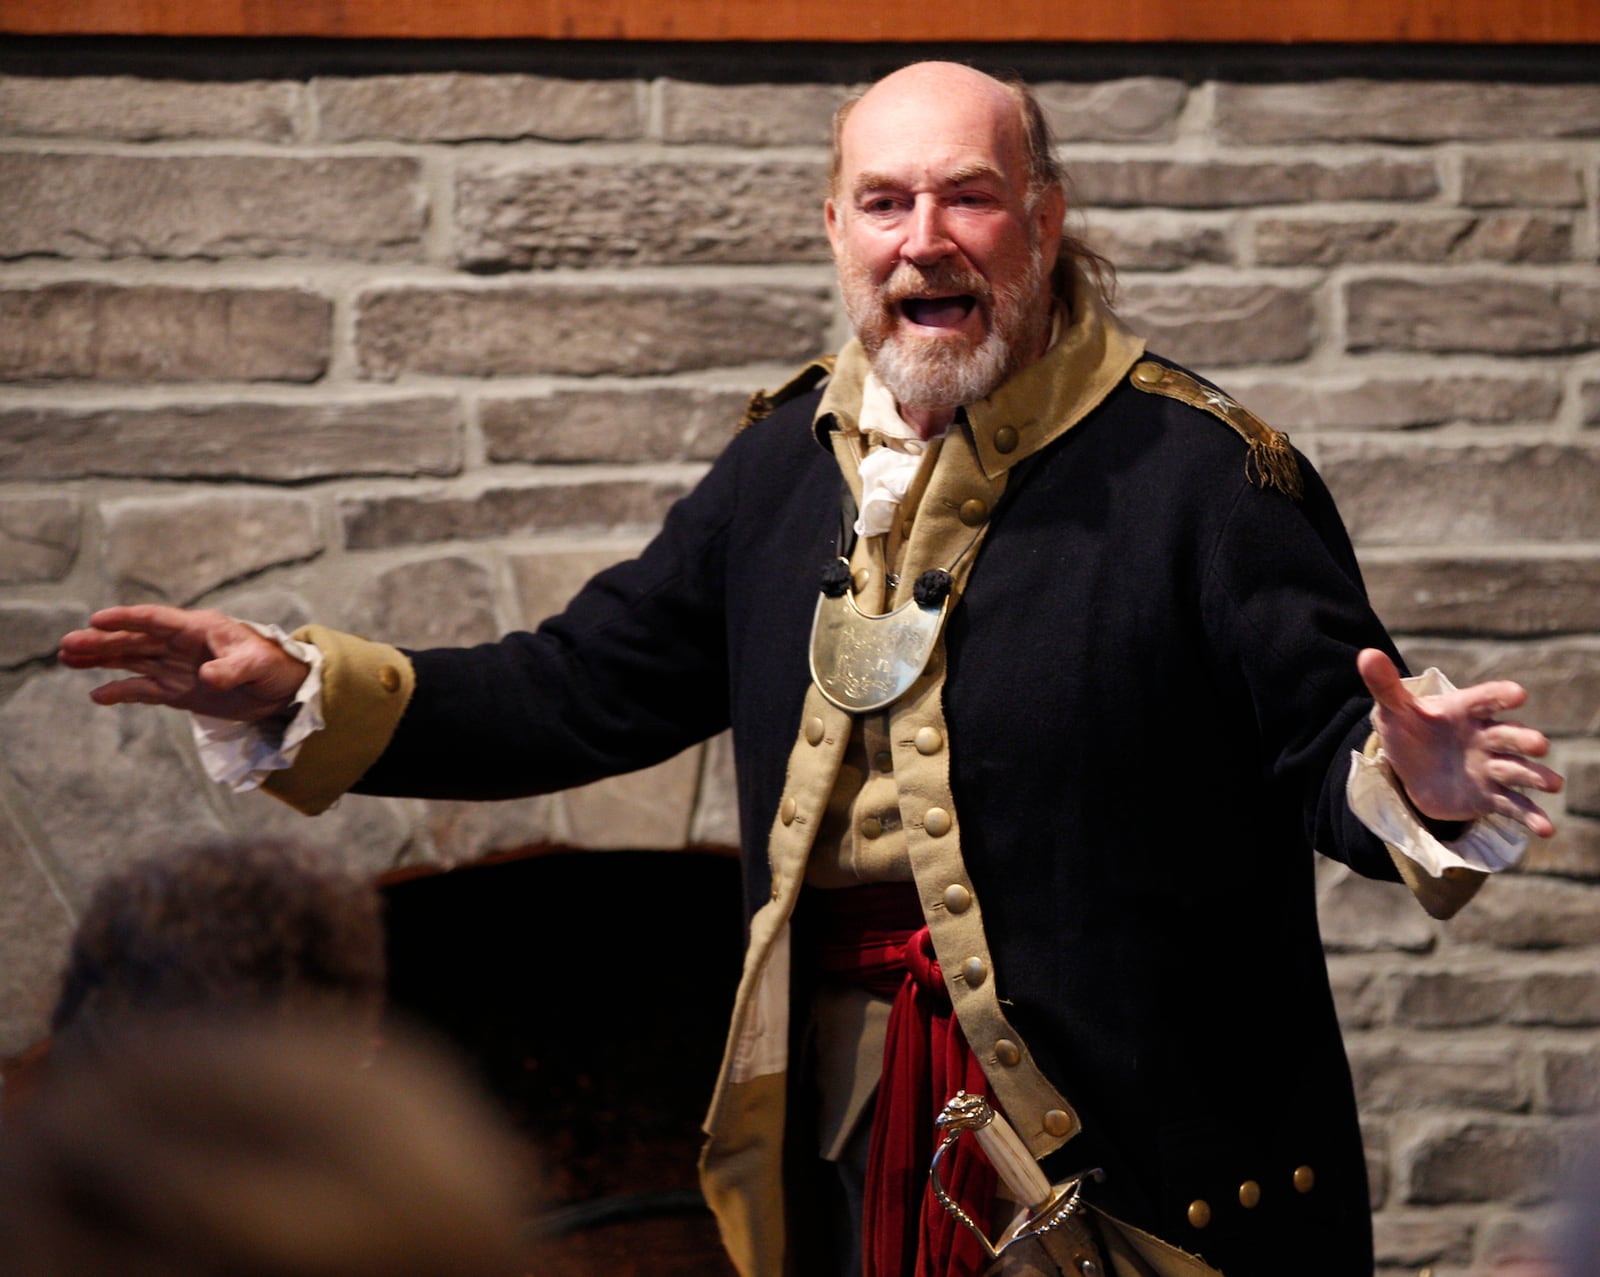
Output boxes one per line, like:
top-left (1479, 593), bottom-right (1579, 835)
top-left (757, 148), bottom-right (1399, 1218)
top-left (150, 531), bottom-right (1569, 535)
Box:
top-left (261, 626), bottom-right (416, 816)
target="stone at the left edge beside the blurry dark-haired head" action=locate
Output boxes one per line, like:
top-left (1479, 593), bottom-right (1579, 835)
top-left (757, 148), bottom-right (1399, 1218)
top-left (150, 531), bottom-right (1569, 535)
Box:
top-left (0, 816), bottom-right (74, 1056)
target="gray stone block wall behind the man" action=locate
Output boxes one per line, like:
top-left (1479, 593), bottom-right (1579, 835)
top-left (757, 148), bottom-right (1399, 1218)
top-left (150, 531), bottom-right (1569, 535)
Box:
top-left (0, 42), bottom-right (1600, 1274)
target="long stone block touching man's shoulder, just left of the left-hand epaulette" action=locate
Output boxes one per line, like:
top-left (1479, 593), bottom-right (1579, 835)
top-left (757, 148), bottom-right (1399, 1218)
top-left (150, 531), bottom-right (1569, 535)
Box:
top-left (478, 386), bottom-right (754, 462)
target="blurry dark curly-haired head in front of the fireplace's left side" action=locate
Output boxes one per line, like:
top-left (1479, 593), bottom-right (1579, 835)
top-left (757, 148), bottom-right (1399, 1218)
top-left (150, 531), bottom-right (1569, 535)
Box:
top-left (51, 840), bottom-right (386, 1058)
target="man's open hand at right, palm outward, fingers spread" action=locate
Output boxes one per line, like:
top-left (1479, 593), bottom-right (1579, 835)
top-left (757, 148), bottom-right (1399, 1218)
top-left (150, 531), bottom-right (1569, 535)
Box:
top-left (1355, 648), bottom-right (1562, 837)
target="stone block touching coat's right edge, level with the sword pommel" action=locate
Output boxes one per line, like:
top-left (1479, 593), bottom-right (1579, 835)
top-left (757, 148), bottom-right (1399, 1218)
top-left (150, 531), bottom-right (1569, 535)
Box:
top-left (1350, 1042), bottom-right (1528, 1114)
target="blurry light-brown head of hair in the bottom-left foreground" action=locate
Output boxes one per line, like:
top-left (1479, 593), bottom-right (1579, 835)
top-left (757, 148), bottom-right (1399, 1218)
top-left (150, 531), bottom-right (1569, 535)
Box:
top-left (0, 1021), bottom-right (522, 1277)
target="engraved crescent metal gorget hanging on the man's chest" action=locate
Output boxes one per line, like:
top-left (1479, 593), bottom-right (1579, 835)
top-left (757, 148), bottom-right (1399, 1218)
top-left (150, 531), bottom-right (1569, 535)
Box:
top-left (811, 578), bottom-right (950, 714)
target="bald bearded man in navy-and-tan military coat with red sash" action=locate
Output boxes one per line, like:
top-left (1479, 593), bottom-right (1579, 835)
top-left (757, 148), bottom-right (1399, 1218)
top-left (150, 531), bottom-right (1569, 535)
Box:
top-left (62, 62), bottom-right (1560, 1277)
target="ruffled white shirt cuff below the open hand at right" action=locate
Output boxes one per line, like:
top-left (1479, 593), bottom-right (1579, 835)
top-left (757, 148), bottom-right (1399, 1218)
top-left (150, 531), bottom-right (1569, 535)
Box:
top-left (1344, 667), bottom-right (1528, 879)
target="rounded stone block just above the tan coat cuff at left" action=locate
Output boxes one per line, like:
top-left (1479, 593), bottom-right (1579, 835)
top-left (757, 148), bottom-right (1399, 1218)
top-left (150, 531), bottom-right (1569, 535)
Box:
top-left (344, 554), bottom-right (501, 648)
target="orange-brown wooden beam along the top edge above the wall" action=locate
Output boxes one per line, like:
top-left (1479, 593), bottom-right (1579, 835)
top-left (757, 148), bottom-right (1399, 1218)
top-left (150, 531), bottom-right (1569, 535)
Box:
top-left (0, 0), bottom-right (1600, 45)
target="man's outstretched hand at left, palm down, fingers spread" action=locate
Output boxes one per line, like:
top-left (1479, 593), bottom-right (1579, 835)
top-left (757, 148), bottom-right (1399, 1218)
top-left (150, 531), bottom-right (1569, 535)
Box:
top-left (59, 605), bottom-right (310, 723)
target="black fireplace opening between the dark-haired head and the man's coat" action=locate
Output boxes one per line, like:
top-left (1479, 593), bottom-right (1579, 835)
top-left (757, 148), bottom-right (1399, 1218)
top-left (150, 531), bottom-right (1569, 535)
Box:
top-left (384, 851), bottom-right (742, 1277)
